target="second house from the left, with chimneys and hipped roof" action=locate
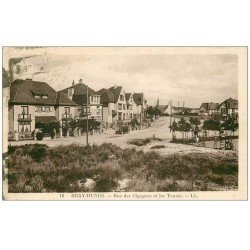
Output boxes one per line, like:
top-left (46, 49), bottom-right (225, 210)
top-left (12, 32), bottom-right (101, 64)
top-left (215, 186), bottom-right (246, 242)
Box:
top-left (60, 79), bottom-right (102, 122)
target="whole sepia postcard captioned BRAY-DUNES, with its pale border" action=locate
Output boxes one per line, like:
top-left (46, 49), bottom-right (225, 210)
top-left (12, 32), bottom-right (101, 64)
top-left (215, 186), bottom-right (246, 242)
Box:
top-left (2, 46), bottom-right (248, 201)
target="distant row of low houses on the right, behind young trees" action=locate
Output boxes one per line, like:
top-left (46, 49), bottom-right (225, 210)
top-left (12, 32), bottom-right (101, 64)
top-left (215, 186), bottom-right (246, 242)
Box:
top-left (157, 98), bottom-right (238, 119)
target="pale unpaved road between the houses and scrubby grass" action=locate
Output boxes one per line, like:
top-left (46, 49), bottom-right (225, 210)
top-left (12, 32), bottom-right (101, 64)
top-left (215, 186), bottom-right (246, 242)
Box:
top-left (9, 117), bottom-right (235, 155)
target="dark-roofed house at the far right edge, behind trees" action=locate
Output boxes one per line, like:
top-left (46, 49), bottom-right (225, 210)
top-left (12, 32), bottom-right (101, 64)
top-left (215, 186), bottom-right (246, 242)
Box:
top-left (216, 98), bottom-right (238, 119)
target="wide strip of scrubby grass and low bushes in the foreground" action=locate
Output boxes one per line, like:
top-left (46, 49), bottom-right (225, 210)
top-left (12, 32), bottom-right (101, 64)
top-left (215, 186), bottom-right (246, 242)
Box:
top-left (8, 144), bottom-right (238, 192)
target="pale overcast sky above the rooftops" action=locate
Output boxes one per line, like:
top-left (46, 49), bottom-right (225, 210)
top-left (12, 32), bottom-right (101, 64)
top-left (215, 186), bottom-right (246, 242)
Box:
top-left (3, 47), bottom-right (238, 107)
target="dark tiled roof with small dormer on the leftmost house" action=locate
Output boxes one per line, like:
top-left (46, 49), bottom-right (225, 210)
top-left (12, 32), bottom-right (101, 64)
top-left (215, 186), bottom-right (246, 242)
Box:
top-left (10, 80), bottom-right (76, 105)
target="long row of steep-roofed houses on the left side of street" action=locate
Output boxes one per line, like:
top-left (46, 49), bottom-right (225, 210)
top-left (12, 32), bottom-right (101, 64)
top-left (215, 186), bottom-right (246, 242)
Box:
top-left (8, 79), bottom-right (147, 135)
